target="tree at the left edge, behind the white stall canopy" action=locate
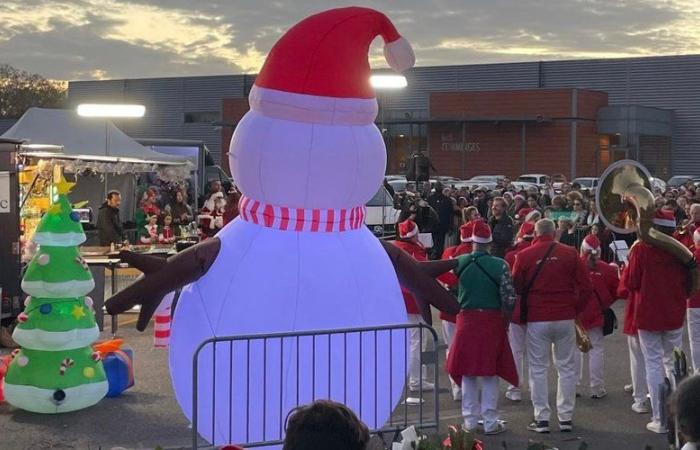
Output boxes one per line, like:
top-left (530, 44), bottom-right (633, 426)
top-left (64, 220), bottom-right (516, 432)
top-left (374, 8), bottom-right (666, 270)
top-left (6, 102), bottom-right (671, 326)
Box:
top-left (0, 64), bottom-right (68, 119)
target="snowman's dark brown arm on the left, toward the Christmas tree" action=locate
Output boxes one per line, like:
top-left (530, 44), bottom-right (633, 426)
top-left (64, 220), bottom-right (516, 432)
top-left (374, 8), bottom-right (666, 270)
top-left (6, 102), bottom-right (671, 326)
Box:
top-left (106, 238), bottom-right (221, 331)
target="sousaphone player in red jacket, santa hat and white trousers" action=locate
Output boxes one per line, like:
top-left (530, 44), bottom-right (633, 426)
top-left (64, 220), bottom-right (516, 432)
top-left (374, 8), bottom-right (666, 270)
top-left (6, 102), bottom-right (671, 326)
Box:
top-left (625, 209), bottom-right (688, 434)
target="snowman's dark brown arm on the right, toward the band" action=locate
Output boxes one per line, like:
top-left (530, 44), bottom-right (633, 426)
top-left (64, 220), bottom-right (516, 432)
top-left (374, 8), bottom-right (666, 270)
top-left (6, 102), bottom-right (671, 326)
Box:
top-left (380, 240), bottom-right (459, 324)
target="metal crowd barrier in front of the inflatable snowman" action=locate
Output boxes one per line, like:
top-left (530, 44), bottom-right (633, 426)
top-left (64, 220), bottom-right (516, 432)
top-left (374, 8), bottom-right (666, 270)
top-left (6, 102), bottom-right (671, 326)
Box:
top-left (192, 324), bottom-right (440, 449)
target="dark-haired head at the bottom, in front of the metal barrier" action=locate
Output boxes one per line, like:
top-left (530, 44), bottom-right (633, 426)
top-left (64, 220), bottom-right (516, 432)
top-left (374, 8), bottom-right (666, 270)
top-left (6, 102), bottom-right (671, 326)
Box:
top-left (282, 400), bottom-right (369, 450)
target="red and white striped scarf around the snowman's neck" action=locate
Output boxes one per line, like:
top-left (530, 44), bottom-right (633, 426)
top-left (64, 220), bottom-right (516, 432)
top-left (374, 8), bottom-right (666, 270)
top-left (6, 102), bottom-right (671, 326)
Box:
top-left (238, 196), bottom-right (366, 233)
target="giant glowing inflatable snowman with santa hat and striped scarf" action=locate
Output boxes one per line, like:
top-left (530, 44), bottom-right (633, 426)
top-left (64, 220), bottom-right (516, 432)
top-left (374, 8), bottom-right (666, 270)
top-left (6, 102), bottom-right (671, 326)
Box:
top-left (108, 7), bottom-right (460, 444)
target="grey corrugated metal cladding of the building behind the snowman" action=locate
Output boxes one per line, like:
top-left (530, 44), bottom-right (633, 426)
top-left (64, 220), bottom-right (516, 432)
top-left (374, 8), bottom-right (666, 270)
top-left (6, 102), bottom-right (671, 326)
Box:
top-left (69, 52), bottom-right (700, 174)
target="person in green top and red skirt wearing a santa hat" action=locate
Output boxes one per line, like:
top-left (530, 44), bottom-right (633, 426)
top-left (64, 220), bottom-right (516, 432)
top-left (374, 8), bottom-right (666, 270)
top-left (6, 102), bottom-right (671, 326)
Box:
top-left (447, 221), bottom-right (518, 434)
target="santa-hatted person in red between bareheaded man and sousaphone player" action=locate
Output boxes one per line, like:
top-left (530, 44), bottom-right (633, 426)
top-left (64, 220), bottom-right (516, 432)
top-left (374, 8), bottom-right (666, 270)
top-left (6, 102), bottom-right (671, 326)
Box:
top-left (576, 234), bottom-right (620, 399)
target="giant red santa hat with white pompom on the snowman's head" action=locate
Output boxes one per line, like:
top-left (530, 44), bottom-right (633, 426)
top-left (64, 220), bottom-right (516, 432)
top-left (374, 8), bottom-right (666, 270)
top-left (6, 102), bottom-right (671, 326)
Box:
top-left (249, 7), bottom-right (415, 125)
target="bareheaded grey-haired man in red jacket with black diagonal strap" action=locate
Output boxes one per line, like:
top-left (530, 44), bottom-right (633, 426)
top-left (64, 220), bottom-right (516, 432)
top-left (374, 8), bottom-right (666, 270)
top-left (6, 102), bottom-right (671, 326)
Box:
top-left (513, 219), bottom-right (592, 433)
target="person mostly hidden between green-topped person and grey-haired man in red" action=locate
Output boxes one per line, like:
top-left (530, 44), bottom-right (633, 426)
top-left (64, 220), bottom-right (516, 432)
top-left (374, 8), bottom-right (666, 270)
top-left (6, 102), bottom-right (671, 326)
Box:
top-left (505, 220), bottom-right (535, 402)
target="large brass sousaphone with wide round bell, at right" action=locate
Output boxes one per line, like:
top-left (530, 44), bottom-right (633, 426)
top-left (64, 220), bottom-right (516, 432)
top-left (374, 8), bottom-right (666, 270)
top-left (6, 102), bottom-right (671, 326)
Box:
top-left (595, 159), bottom-right (698, 293)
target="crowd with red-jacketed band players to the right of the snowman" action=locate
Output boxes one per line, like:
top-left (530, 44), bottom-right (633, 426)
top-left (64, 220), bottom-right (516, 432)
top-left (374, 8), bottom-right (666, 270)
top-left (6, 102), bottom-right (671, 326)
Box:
top-left (394, 176), bottom-right (700, 440)
